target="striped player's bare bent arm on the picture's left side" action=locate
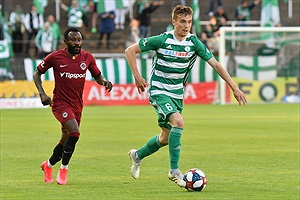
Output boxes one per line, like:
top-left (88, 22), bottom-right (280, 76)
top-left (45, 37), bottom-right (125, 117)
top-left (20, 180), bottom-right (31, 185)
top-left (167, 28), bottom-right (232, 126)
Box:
top-left (125, 43), bottom-right (147, 94)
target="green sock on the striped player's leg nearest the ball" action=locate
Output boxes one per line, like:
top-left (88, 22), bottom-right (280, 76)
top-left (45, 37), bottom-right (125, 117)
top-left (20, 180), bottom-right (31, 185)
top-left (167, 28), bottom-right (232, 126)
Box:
top-left (169, 127), bottom-right (183, 169)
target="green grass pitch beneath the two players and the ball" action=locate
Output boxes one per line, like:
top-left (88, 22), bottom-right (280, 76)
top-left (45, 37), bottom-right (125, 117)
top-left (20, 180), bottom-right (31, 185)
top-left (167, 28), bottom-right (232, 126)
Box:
top-left (0, 104), bottom-right (300, 200)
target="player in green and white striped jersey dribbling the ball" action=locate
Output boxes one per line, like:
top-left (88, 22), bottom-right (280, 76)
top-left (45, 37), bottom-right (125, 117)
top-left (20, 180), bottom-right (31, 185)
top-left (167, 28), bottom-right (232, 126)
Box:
top-left (125, 5), bottom-right (247, 187)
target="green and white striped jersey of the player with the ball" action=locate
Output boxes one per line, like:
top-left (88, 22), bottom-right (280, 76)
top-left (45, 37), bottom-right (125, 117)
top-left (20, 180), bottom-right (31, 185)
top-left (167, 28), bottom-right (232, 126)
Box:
top-left (139, 30), bottom-right (213, 99)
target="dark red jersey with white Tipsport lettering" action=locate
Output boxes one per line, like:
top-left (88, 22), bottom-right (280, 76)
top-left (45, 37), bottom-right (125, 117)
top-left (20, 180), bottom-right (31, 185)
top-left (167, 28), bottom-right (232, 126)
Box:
top-left (38, 49), bottom-right (100, 110)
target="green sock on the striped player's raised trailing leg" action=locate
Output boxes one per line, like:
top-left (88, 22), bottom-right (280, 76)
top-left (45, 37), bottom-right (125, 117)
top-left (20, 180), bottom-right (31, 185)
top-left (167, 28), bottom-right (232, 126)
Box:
top-left (136, 135), bottom-right (164, 159)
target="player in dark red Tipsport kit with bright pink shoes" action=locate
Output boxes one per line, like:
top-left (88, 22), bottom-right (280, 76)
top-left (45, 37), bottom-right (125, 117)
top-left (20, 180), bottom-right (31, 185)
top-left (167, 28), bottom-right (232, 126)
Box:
top-left (33, 27), bottom-right (113, 185)
